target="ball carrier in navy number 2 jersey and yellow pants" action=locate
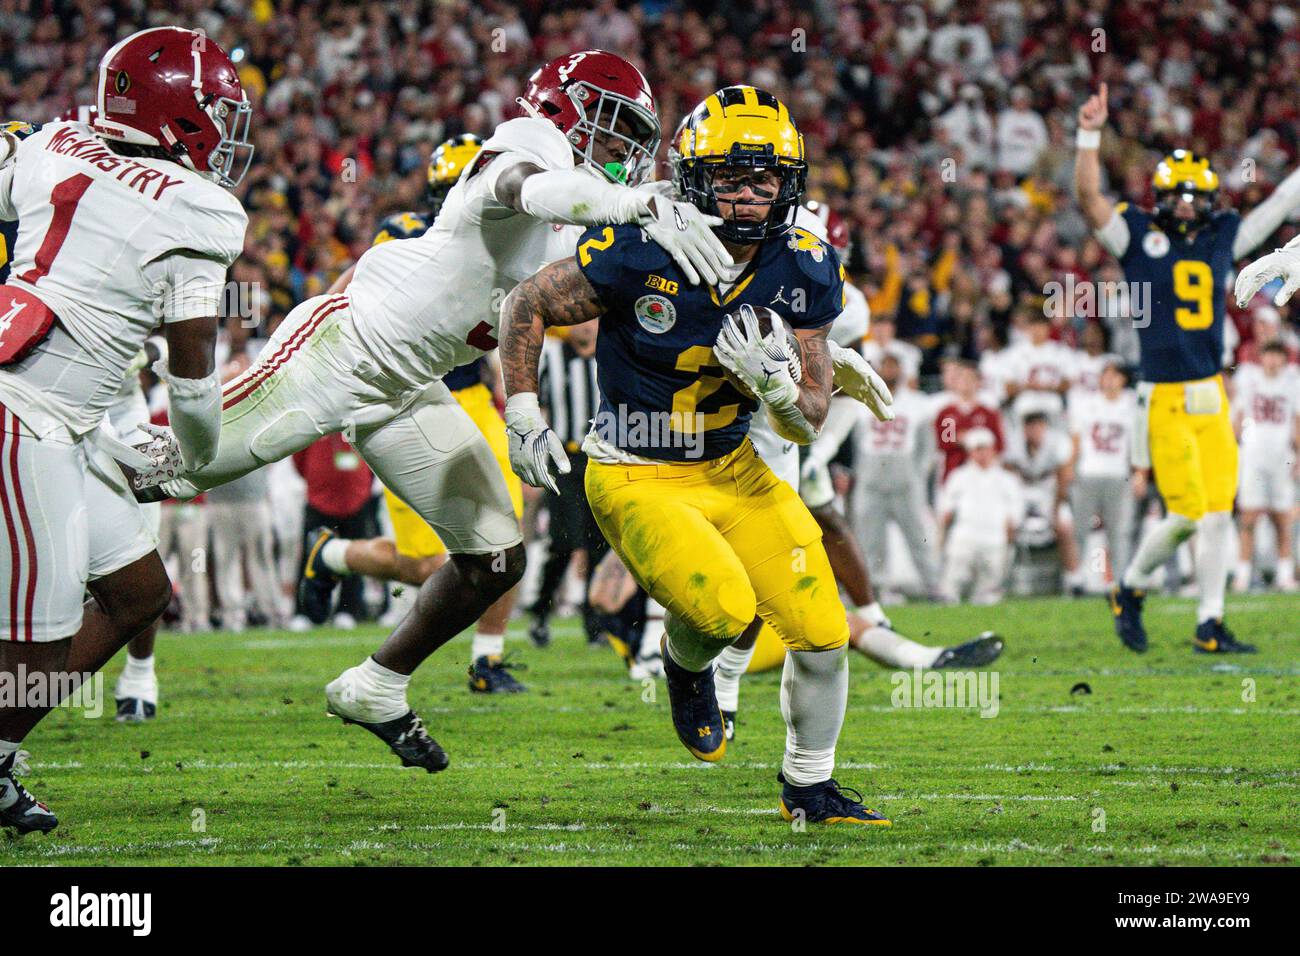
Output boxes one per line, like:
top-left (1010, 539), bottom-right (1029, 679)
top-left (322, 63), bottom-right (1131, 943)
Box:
top-left (501, 86), bottom-right (889, 826)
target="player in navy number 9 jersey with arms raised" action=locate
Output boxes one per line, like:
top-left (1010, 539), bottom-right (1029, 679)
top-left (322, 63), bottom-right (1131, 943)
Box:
top-left (1075, 83), bottom-right (1300, 654)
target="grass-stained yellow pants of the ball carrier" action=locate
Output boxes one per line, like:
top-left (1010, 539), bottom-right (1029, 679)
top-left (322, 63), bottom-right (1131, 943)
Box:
top-left (586, 440), bottom-right (849, 650)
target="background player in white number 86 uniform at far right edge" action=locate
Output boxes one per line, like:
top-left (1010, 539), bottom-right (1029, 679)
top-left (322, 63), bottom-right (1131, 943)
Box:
top-left (1232, 339), bottom-right (1300, 591)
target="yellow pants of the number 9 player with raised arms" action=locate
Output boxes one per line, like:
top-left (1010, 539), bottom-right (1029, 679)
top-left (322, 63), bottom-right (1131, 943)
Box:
top-left (1147, 376), bottom-right (1238, 522)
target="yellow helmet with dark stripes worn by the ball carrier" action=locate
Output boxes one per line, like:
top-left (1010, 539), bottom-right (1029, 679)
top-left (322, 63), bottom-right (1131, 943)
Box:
top-left (672, 86), bottom-right (807, 243)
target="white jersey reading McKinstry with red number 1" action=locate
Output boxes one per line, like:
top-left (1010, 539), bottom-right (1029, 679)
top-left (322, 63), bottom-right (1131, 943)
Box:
top-left (0, 122), bottom-right (248, 429)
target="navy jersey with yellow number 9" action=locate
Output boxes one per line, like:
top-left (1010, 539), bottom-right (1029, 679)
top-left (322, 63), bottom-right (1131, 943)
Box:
top-left (1118, 206), bottom-right (1242, 382)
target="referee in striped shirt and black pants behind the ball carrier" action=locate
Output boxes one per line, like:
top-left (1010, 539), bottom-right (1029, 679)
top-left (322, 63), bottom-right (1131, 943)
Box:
top-left (528, 321), bottom-right (608, 648)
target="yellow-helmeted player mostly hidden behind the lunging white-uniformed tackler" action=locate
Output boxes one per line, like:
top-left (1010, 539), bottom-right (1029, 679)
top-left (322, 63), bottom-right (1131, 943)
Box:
top-left (298, 133), bottom-right (525, 693)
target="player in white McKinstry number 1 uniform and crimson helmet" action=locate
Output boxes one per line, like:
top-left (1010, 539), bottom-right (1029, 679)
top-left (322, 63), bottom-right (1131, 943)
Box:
top-left (0, 27), bottom-right (252, 832)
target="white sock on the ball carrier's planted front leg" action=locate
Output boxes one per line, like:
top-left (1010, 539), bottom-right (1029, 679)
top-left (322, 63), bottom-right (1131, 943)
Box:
top-left (781, 648), bottom-right (849, 787)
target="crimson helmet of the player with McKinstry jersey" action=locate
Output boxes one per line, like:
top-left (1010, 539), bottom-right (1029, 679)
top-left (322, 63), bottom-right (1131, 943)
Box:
top-left (94, 26), bottom-right (252, 186)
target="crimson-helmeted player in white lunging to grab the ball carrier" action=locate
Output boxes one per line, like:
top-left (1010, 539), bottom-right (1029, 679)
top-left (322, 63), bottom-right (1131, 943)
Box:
top-left (139, 51), bottom-right (732, 773)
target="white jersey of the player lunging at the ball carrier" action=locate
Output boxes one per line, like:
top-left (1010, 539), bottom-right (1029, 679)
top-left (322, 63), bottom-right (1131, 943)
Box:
top-left (347, 117), bottom-right (582, 388)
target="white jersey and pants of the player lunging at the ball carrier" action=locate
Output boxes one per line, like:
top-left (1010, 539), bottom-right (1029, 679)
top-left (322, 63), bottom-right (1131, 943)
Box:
top-left (164, 117), bottom-right (582, 554)
